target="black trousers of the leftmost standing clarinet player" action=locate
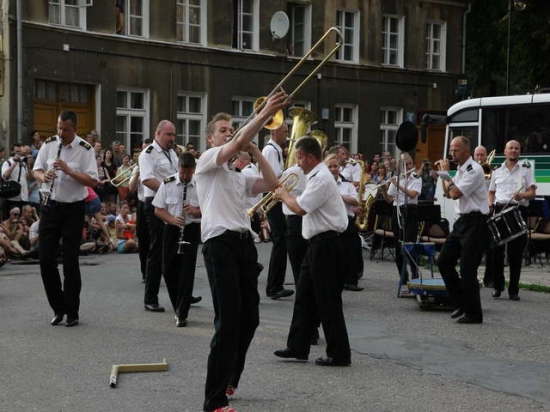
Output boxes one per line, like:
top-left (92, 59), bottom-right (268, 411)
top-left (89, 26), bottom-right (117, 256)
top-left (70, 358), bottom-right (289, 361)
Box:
top-left (38, 201), bottom-right (84, 319)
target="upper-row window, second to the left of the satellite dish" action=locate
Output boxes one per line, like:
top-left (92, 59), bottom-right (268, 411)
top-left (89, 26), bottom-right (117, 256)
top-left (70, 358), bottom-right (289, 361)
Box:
top-left (176, 0), bottom-right (206, 44)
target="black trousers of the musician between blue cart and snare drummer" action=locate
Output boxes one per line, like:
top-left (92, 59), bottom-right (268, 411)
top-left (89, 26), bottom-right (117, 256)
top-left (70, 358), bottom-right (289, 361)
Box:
top-left (437, 213), bottom-right (489, 320)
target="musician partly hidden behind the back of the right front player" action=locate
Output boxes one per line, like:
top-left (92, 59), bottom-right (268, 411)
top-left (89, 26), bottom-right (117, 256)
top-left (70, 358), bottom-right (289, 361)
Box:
top-left (325, 154), bottom-right (363, 292)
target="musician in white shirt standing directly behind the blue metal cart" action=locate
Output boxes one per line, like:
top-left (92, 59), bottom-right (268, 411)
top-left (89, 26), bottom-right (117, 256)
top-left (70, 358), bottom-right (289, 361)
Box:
top-left (380, 153), bottom-right (422, 294)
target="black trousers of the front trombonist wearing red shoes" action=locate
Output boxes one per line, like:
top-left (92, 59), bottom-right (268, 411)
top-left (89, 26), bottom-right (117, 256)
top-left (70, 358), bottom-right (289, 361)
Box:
top-left (202, 232), bottom-right (260, 411)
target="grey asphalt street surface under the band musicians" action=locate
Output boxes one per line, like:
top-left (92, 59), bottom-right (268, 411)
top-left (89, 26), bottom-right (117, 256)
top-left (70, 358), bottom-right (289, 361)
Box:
top-left (0, 244), bottom-right (550, 412)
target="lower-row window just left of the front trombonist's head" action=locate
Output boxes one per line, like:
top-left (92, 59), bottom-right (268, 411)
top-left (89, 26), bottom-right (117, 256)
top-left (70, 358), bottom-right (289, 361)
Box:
top-left (176, 93), bottom-right (206, 151)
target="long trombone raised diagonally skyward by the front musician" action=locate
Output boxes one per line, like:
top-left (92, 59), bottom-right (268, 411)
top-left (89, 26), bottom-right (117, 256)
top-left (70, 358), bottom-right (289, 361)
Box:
top-left (227, 27), bottom-right (344, 142)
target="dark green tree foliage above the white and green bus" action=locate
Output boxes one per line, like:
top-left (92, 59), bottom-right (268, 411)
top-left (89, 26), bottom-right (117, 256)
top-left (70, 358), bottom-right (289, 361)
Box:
top-left (466, 0), bottom-right (550, 97)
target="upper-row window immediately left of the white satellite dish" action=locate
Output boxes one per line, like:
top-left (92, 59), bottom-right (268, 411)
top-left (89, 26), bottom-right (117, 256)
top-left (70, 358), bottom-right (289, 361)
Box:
top-left (233, 0), bottom-right (260, 50)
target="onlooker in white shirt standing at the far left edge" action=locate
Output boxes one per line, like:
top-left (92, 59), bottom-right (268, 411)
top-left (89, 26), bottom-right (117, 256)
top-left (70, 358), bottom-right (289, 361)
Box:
top-left (2, 143), bottom-right (32, 219)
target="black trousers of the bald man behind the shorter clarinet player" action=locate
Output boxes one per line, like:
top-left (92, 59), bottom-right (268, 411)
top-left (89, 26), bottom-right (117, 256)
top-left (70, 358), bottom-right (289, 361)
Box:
top-left (143, 197), bottom-right (164, 305)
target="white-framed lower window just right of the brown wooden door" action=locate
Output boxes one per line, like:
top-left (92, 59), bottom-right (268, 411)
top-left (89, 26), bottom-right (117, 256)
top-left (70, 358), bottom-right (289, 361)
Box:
top-left (116, 89), bottom-right (149, 153)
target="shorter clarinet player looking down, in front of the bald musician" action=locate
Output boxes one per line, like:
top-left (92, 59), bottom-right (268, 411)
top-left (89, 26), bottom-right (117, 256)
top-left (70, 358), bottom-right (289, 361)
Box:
top-left (153, 152), bottom-right (201, 328)
